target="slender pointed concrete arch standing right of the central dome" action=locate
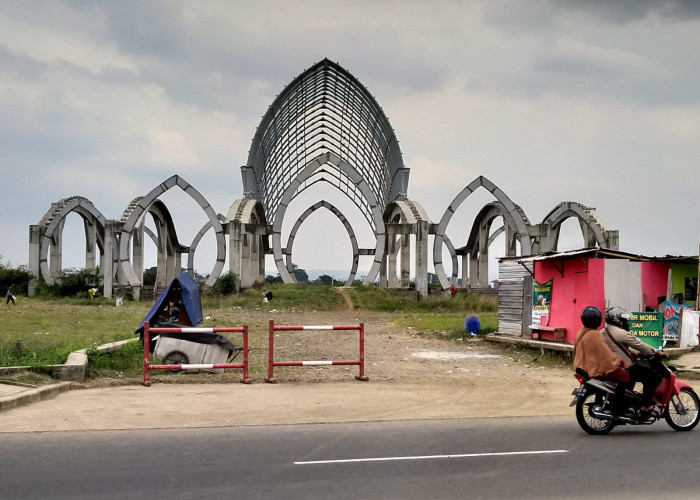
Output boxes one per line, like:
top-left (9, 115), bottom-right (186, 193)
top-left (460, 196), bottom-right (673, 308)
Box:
top-left (433, 176), bottom-right (532, 288)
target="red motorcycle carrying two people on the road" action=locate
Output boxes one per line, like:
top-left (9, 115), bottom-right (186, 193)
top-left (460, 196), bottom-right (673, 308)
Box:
top-left (569, 356), bottom-right (700, 435)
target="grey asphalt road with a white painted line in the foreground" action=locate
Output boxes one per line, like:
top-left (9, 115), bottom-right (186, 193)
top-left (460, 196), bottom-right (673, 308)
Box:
top-left (0, 417), bottom-right (700, 500)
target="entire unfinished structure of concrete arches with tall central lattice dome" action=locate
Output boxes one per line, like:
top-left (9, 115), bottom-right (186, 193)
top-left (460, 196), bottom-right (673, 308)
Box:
top-left (29, 59), bottom-right (618, 299)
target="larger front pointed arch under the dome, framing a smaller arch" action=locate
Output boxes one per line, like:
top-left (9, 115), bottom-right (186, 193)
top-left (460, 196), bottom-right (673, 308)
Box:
top-left (272, 153), bottom-right (386, 284)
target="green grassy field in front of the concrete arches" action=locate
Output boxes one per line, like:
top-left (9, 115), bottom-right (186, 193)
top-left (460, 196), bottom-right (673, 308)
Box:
top-left (0, 285), bottom-right (497, 377)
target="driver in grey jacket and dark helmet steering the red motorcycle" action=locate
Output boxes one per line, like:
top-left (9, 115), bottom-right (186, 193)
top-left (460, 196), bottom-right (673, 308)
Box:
top-left (601, 307), bottom-right (668, 412)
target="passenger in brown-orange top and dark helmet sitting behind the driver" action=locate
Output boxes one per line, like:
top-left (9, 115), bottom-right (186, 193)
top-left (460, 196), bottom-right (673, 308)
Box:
top-left (574, 306), bottom-right (630, 414)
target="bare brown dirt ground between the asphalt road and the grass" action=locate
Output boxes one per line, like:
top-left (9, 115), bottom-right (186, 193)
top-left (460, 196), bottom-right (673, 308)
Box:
top-left (0, 308), bottom-right (576, 432)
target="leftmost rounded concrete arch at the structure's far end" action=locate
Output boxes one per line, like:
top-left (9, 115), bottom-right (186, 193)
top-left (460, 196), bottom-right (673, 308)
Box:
top-left (37, 196), bottom-right (107, 285)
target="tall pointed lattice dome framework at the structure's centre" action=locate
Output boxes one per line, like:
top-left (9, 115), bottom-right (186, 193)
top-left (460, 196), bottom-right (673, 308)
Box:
top-left (241, 59), bottom-right (418, 290)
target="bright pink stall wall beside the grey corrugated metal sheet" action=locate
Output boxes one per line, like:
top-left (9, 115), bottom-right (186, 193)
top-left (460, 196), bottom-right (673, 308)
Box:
top-left (534, 258), bottom-right (605, 344)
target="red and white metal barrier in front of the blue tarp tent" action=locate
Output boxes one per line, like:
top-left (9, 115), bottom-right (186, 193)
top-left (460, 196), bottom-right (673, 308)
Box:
top-left (143, 321), bottom-right (252, 387)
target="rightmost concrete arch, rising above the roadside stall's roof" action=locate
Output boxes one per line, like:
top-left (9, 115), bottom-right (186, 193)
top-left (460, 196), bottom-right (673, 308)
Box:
top-left (540, 201), bottom-right (618, 252)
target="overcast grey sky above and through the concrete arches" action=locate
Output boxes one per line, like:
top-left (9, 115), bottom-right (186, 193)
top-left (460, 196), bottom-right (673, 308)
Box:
top-left (0, 0), bottom-right (700, 282)
